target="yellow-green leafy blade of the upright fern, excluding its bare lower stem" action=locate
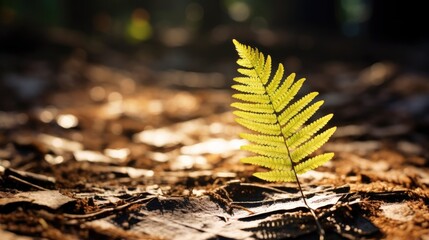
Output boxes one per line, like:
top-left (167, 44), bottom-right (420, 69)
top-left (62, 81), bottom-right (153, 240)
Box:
top-left (231, 39), bottom-right (336, 182)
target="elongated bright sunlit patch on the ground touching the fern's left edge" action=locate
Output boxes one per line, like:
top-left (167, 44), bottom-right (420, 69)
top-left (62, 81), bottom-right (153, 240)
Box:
top-left (180, 138), bottom-right (246, 155)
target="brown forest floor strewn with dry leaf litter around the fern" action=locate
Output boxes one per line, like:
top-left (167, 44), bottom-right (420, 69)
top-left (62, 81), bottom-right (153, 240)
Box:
top-left (0, 32), bottom-right (429, 240)
